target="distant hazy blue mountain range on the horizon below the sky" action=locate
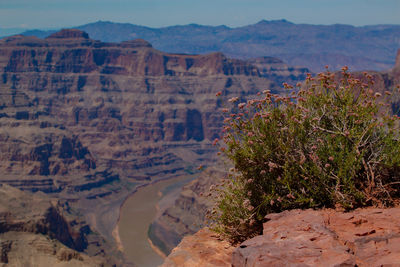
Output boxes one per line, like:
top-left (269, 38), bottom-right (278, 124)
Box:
top-left (6, 20), bottom-right (400, 71)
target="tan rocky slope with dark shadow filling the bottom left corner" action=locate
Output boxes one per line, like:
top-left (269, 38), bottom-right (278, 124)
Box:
top-left (0, 185), bottom-right (121, 266)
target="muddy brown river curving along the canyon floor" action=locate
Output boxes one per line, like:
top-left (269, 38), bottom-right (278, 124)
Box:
top-left (118, 176), bottom-right (190, 267)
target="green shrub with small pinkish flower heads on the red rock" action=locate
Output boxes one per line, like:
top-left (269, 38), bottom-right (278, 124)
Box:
top-left (213, 68), bottom-right (400, 242)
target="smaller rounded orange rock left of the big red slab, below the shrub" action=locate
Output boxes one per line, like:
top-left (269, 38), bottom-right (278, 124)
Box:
top-left (160, 228), bottom-right (234, 267)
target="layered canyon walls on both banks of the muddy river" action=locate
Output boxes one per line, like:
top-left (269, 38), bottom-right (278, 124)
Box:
top-left (0, 24), bottom-right (400, 266)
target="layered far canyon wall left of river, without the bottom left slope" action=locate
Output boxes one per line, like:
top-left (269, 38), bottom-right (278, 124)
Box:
top-left (0, 29), bottom-right (308, 264)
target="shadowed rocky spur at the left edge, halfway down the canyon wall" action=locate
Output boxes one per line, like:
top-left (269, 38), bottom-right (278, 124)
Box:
top-left (0, 134), bottom-right (96, 186)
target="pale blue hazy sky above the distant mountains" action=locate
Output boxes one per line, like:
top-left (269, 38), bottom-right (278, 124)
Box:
top-left (0, 0), bottom-right (400, 28)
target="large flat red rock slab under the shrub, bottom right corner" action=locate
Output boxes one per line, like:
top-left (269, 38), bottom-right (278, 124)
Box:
top-left (232, 208), bottom-right (400, 267)
